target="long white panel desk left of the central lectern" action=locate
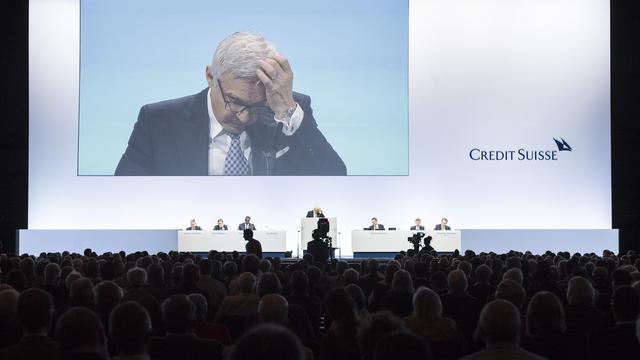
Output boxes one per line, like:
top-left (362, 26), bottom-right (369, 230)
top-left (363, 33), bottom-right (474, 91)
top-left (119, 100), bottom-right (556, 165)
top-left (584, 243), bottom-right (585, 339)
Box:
top-left (178, 230), bottom-right (287, 252)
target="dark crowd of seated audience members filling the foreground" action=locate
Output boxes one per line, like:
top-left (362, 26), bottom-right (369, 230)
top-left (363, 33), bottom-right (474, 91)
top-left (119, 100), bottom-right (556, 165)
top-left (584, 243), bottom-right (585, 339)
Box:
top-left (0, 249), bottom-right (640, 360)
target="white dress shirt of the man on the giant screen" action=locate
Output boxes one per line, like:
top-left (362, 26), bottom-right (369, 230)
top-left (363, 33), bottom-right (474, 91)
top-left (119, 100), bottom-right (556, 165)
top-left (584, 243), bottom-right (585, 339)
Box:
top-left (207, 88), bottom-right (304, 175)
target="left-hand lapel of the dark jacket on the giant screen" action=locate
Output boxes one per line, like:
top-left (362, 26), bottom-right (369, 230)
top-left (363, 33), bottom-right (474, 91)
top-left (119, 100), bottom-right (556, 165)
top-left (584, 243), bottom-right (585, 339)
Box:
top-left (175, 88), bottom-right (209, 175)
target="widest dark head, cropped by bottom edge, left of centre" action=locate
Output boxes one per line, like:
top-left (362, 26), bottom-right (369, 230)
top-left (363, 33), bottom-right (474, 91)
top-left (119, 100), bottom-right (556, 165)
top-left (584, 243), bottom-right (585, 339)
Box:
top-left (230, 323), bottom-right (304, 360)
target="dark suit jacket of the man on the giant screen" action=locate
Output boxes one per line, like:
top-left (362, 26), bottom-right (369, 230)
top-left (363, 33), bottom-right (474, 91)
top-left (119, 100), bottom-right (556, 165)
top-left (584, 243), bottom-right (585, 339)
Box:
top-left (115, 89), bottom-right (347, 175)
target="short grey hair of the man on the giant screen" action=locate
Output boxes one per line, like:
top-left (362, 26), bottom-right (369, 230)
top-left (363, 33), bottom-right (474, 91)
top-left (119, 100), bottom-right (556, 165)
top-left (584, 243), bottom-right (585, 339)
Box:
top-left (210, 31), bottom-right (276, 81)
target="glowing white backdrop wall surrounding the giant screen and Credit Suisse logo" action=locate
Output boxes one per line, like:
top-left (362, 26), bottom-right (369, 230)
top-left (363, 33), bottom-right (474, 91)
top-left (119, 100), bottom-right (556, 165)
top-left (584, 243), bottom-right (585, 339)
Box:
top-left (29, 0), bottom-right (611, 253)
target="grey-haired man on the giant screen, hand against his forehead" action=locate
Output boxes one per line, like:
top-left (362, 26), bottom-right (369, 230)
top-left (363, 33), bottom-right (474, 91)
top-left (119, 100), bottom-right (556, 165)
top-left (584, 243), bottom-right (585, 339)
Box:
top-left (115, 32), bottom-right (347, 175)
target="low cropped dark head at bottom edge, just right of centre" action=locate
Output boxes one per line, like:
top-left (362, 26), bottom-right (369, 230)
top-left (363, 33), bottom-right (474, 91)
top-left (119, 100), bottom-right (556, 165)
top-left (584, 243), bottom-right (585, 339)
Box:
top-left (373, 331), bottom-right (433, 360)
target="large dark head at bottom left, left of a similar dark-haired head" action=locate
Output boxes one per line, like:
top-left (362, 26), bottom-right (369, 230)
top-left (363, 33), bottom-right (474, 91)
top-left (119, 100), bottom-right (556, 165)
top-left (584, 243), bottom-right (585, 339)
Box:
top-left (56, 306), bottom-right (108, 358)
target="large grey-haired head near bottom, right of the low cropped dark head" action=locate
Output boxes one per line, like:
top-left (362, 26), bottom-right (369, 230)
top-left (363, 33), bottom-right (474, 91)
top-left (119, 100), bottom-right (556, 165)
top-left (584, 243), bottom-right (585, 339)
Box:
top-left (474, 300), bottom-right (520, 346)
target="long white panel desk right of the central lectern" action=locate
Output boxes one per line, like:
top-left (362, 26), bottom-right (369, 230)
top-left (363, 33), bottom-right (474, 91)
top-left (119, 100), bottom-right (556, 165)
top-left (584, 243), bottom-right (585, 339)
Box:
top-left (351, 230), bottom-right (461, 253)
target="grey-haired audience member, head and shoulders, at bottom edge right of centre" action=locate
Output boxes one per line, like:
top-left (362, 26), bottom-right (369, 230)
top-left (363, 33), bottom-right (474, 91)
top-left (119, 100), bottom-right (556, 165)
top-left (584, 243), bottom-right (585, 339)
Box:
top-left (463, 300), bottom-right (544, 360)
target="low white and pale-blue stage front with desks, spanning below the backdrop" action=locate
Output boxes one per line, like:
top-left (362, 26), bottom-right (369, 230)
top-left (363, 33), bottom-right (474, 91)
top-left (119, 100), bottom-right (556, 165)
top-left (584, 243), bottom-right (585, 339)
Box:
top-left (17, 229), bottom-right (618, 259)
